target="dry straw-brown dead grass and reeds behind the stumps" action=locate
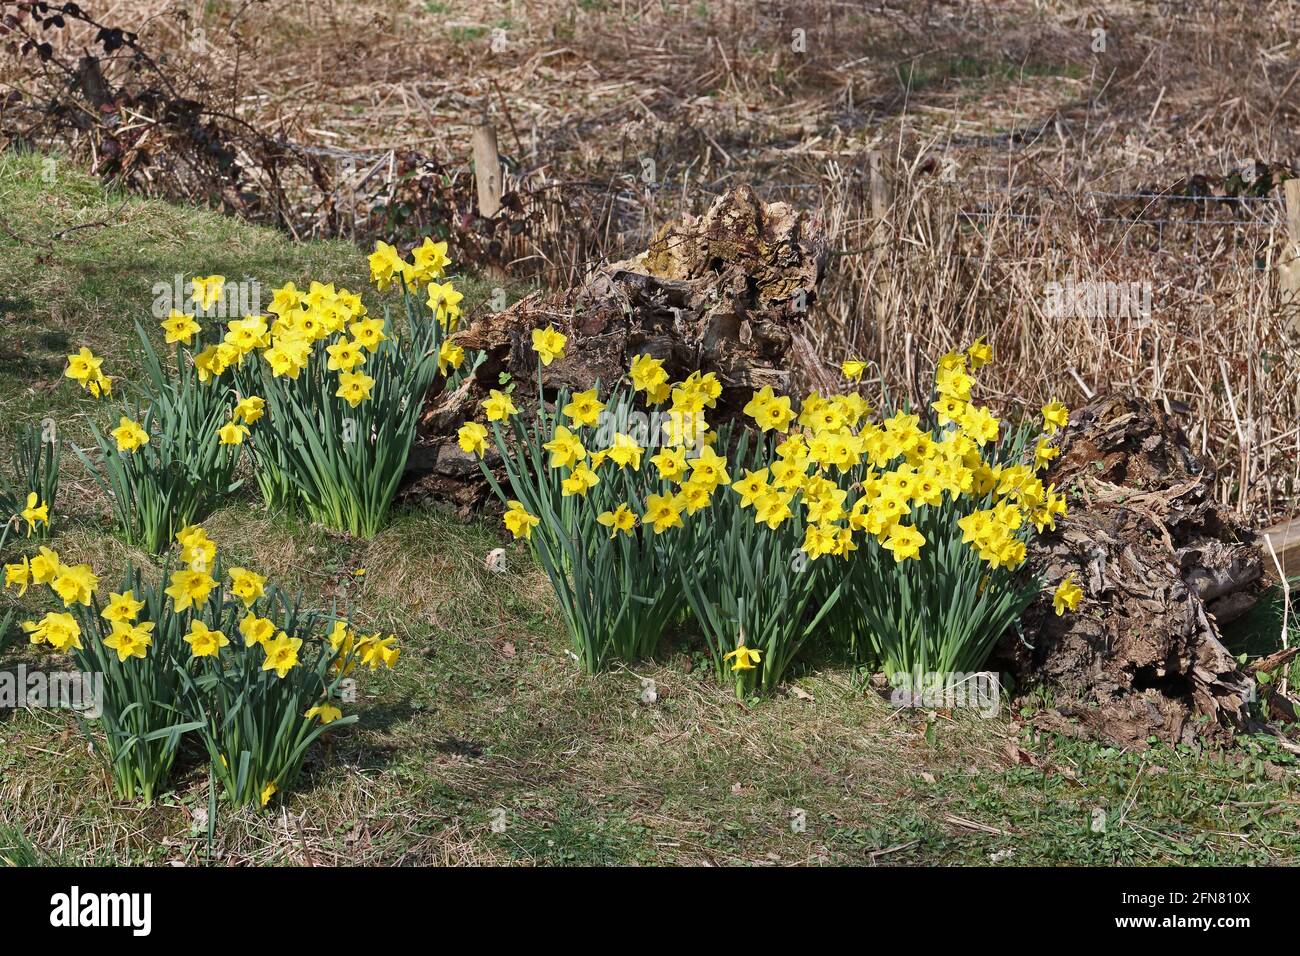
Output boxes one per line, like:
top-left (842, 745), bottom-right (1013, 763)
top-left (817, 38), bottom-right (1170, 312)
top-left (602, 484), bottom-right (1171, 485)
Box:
top-left (0, 0), bottom-right (1300, 522)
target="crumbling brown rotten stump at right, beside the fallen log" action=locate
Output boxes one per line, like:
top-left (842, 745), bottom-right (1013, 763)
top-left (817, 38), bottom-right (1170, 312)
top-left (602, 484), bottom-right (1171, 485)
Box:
top-left (1001, 397), bottom-right (1262, 747)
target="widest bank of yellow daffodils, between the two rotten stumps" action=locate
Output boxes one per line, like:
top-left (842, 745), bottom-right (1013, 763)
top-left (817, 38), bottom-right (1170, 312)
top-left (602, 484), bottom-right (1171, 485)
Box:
top-left (459, 328), bottom-right (1080, 689)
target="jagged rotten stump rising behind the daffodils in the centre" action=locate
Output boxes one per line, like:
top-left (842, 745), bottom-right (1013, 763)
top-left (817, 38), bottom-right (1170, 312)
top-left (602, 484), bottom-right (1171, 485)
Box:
top-left (410, 186), bottom-right (826, 511)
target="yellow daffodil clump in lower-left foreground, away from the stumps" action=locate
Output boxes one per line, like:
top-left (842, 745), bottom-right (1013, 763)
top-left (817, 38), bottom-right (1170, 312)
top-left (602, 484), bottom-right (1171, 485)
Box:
top-left (5, 525), bottom-right (400, 805)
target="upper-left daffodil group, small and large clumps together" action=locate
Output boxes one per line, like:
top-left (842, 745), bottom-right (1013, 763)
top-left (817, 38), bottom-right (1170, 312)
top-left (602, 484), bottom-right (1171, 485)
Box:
top-left (65, 238), bottom-right (467, 553)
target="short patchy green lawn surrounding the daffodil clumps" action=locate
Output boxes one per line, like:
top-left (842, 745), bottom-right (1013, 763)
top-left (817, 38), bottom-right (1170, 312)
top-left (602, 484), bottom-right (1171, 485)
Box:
top-left (0, 155), bottom-right (1300, 865)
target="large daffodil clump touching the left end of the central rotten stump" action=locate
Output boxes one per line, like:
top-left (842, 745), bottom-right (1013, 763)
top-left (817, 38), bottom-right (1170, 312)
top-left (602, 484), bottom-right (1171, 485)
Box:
top-left (226, 238), bottom-right (465, 537)
